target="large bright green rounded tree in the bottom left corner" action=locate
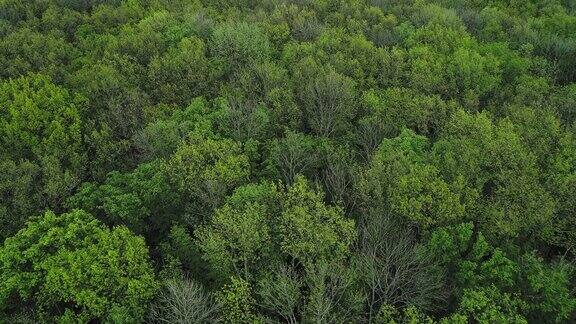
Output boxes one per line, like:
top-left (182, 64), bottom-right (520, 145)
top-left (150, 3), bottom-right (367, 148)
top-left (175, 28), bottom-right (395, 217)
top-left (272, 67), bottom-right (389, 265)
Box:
top-left (0, 210), bottom-right (157, 321)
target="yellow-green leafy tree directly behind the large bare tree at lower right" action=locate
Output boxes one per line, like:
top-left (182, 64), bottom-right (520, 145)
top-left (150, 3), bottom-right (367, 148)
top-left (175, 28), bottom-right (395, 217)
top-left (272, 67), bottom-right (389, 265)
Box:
top-left (358, 129), bottom-right (465, 231)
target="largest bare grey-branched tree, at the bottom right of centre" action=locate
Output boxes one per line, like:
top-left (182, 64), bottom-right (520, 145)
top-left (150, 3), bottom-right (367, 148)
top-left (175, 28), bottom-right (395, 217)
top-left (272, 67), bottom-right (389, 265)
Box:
top-left (357, 215), bottom-right (445, 322)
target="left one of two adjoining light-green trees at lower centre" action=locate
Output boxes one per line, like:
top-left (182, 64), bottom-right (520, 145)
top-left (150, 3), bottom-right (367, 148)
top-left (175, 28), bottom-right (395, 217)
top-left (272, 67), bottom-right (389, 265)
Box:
top-left (196, 183), bottom-right (278, 281)
